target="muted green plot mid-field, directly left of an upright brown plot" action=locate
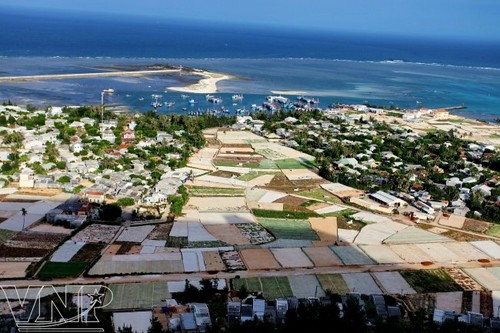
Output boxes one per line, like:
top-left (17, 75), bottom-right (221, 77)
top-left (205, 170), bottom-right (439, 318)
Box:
top-left (257, 218), bottom-right (319, 240)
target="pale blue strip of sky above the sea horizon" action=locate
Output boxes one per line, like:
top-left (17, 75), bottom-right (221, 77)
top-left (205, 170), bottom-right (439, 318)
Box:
top-left (0, 0), bottom-right (500, 41)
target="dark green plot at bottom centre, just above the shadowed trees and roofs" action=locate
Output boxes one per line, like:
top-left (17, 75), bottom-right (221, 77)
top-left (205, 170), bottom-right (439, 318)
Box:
top-left (232, 276), bottom-right (293, 300)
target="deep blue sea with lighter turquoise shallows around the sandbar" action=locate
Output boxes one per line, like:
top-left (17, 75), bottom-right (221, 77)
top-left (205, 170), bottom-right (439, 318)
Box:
top-left (0, 7), bottom-right (500, 120)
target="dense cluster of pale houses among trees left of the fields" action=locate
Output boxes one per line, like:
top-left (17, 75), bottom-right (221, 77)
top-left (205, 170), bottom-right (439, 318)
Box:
top-left (0, 106), bottom-right (193, 204)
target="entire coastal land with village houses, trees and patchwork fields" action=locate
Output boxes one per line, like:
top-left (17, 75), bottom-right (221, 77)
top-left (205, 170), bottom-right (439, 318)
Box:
top-left (0, 96), bottom-right (500, 332)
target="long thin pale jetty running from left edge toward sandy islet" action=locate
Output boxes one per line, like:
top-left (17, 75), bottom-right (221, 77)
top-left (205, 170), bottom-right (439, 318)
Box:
top-left (0, 69), bottom-right (180, 82)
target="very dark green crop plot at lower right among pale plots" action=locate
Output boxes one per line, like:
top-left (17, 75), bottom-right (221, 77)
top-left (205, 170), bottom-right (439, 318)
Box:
top-left (401, 268), bottom-right (463, 293)
